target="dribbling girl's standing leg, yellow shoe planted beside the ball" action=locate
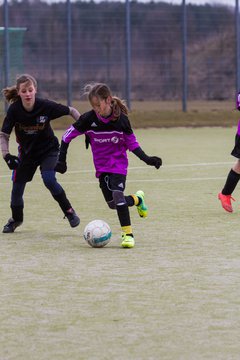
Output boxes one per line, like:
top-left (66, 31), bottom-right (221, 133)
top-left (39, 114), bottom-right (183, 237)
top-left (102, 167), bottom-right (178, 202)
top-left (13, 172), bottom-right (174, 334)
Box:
top-left (99, 174), bottom-right (135, 248)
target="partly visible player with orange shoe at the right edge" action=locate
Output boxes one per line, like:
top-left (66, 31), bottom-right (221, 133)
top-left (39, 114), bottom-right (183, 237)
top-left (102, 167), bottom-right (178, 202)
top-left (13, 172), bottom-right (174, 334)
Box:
top-left (218, 93), bottom-right (240, 212)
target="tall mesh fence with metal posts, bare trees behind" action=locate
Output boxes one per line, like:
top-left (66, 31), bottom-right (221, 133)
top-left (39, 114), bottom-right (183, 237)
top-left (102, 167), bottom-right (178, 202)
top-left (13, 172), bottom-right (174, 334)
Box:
top-left (0, 0), bottom-right (239, 111)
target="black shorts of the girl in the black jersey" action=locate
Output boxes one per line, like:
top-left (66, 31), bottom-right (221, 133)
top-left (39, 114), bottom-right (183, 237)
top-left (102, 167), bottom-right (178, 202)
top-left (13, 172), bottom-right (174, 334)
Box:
top-left (12, 150), bottom-right (58, 182)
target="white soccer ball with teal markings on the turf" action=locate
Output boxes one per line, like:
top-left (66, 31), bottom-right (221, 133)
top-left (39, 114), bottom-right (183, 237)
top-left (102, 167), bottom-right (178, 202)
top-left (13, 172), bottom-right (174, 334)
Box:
top-left (83, 220), bottom-right (112, 247)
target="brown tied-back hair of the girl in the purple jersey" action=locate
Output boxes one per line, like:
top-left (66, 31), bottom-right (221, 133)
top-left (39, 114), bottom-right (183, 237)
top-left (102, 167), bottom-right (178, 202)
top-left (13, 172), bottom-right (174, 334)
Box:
top-left (84, 83), bottom-right (128, 118)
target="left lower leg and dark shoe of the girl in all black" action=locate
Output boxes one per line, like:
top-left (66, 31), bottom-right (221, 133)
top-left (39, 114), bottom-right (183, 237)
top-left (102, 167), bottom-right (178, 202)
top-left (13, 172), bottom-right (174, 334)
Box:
top-left (3, 182), bottom-right (26, 233)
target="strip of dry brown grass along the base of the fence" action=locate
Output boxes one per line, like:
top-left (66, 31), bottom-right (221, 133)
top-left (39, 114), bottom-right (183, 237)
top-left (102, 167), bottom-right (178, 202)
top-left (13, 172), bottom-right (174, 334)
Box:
top-left (0, 101), bottom-right (238, 129)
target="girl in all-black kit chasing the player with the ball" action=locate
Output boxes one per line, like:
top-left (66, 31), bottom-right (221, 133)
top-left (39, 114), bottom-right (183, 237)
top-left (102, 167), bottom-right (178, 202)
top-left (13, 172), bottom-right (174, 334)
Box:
top-left (0, 74), bottom-right (80, 233)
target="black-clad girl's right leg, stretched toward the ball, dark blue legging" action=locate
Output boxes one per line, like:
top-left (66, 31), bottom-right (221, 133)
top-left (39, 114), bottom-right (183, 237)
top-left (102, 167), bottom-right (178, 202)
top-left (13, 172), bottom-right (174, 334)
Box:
top-left (40, 151), bottom-right (80, 227)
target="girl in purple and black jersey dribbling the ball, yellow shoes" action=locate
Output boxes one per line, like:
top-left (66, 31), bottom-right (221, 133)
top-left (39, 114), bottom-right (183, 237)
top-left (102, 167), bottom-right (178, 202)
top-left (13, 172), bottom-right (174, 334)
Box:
top-left (55, 83), bottom-right (162, 248)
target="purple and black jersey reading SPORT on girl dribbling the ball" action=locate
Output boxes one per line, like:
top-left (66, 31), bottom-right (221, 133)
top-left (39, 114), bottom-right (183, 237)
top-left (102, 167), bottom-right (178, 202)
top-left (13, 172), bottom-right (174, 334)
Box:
top-left (62, 110), bottom-right (139, 177)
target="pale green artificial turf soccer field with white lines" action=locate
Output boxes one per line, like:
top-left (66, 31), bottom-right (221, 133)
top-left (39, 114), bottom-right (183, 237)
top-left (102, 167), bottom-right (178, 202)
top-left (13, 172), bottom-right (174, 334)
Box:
top-left (0, 128), bottom-right (240, 360)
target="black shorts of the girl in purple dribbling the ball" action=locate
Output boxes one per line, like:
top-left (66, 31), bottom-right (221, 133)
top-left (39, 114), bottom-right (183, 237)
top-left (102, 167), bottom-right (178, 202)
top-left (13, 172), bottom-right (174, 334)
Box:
top-left (99, 173), bottom-right (126, 202)
